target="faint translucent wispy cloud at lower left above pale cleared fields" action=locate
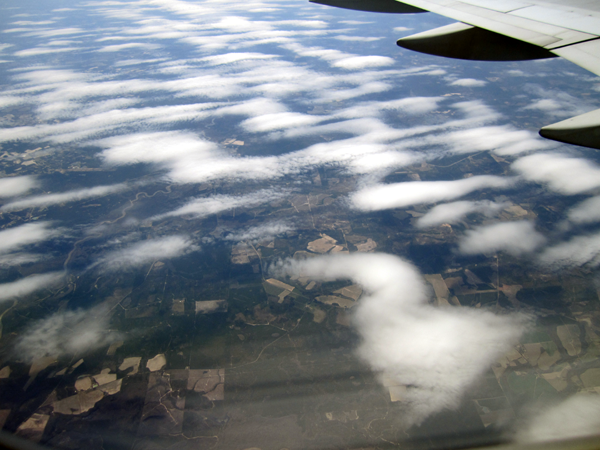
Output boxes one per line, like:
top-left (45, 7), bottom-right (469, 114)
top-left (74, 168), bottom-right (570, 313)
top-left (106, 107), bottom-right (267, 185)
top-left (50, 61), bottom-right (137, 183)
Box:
top-left (15, 307), bottom-right (119, 362)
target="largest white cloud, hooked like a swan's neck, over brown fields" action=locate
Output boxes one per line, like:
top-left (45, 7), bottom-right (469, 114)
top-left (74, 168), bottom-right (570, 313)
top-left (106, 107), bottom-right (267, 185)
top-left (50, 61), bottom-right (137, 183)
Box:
top-left (277, 254), bottom-right (524, 426)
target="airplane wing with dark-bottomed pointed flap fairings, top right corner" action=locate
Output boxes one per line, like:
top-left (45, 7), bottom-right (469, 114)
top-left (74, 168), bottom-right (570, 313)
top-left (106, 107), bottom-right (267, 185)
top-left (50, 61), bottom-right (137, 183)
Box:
top-left (310, 0), bottom-right (600, 149)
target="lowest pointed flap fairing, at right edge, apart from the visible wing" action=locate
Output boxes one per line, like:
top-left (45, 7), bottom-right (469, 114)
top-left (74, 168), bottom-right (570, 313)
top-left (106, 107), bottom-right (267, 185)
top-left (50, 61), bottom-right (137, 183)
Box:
top-left (540, 109), bottom-right (600, 149)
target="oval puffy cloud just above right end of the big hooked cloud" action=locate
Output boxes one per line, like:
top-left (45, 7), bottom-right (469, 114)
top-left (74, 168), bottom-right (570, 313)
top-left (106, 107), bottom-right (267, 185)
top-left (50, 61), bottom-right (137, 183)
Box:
top-left (459, 220), bottom-right (546, 255)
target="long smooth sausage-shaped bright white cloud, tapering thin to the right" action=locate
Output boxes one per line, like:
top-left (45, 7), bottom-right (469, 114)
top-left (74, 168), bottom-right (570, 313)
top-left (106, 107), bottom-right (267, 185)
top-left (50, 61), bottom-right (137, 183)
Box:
top-left (351, 175), bottom-right (514, 211)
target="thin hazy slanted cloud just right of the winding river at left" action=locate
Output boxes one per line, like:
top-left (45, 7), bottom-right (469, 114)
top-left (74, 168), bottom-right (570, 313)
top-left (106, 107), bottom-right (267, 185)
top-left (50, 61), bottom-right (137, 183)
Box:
top-left (92, 235), bottom-right (199, 271)
